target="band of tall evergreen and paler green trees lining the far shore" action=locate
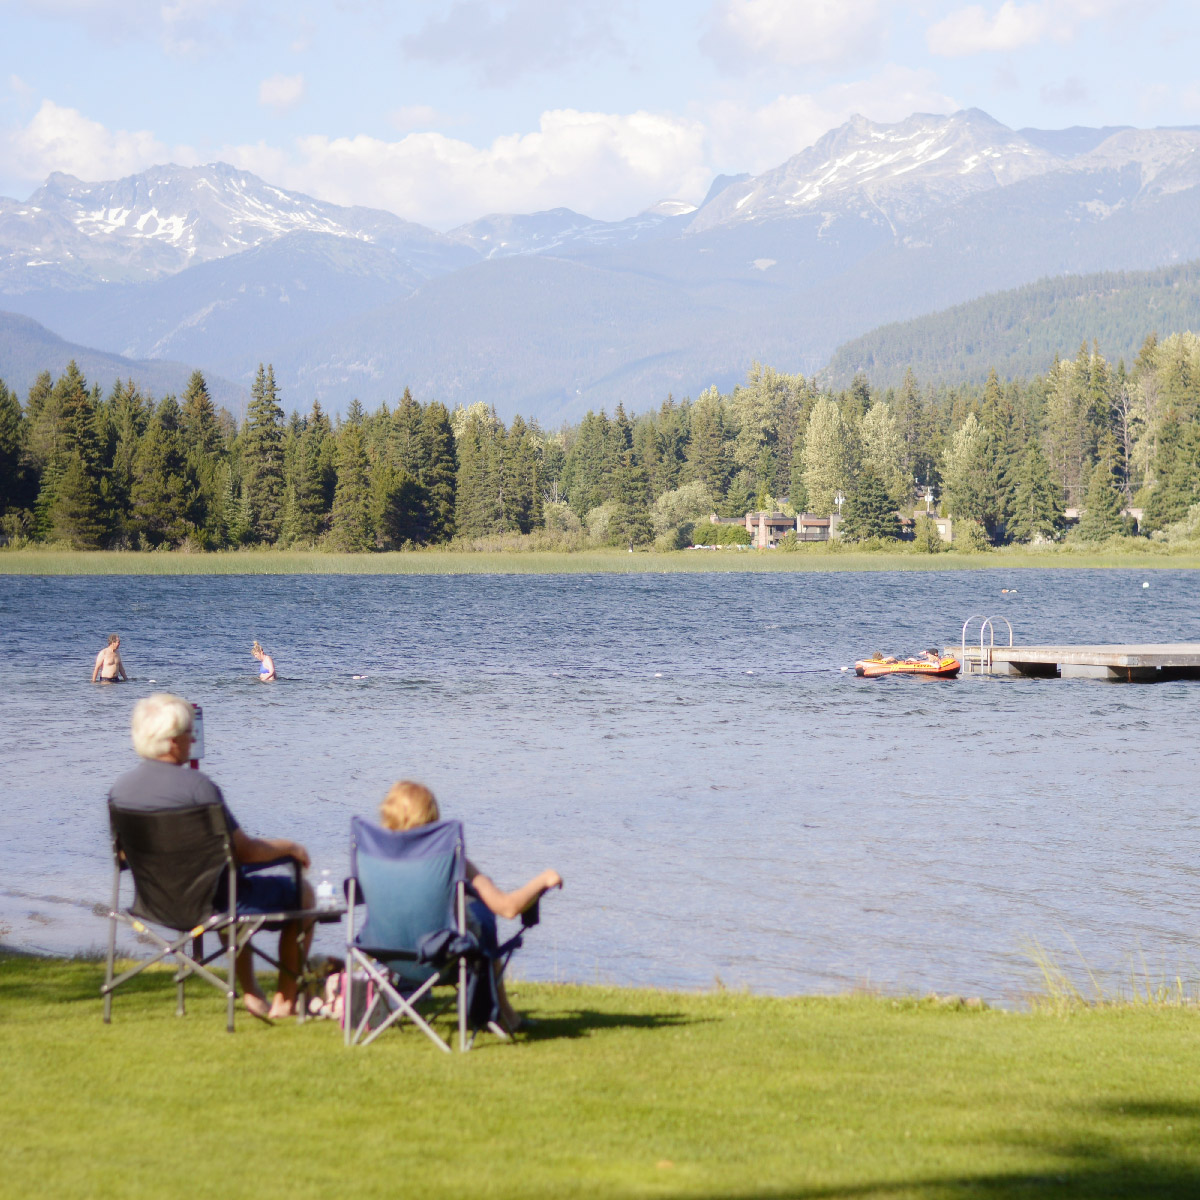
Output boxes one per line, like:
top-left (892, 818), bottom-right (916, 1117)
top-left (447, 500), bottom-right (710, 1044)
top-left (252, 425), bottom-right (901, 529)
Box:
top-left (0, 332), bottom-right (1200, 551)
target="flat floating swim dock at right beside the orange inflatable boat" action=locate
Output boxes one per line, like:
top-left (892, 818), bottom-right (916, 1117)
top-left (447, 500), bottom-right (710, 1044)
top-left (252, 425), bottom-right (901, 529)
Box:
top-left (953, 642), bottom-right (1200, 683)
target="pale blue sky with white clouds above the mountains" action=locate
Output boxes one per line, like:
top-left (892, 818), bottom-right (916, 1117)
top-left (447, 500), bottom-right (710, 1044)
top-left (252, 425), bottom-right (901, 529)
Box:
top-left (0, 0), bottom-right (1200, 228)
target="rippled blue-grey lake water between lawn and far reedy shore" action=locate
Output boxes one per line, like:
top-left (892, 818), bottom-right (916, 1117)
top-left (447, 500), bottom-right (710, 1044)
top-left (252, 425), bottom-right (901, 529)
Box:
top-left (0, 570), bottom-right (1200, 1003)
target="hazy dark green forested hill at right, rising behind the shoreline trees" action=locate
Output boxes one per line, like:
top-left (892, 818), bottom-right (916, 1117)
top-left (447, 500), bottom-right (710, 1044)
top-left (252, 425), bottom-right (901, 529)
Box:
top-left (822, 262), bottom-right (1200, 388)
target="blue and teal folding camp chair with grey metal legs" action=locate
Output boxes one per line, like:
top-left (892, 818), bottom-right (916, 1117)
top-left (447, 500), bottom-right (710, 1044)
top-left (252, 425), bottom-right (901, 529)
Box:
top-left (344, 817), bottom-right (521, 1054)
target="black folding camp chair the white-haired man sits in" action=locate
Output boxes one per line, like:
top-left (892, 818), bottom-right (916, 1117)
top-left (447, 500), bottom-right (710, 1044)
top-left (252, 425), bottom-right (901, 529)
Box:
top-left (100, 804), bottom-right (328, 1033)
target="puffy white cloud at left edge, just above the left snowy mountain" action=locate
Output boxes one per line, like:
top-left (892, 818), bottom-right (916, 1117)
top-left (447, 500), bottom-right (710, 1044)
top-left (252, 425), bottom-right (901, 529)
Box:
top-left (0, 100), bottom-right (180, 182)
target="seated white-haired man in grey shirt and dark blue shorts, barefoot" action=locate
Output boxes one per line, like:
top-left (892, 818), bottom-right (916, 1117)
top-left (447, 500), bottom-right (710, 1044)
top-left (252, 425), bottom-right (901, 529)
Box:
top-left (108, 691), bottom-right (312, 1018)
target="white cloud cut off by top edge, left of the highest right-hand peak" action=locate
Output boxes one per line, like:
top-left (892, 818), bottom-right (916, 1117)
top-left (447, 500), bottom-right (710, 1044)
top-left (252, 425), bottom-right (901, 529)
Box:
top-left (701, 0), bottom-right (883, 67)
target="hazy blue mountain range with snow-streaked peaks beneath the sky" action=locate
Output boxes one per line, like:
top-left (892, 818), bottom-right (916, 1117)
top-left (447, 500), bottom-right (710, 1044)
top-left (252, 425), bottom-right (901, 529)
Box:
top-left (0, 109), bottom-right (1200, 425)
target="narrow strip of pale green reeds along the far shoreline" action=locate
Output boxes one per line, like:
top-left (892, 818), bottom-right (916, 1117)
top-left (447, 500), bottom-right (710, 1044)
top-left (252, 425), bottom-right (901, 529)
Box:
top-left (0, 542), bottom-right (1200, 575)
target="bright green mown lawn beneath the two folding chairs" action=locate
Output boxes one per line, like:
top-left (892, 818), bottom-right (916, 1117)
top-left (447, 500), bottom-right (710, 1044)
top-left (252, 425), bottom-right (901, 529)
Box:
top-left (0, 959), bottom-right (1200, 1200)
